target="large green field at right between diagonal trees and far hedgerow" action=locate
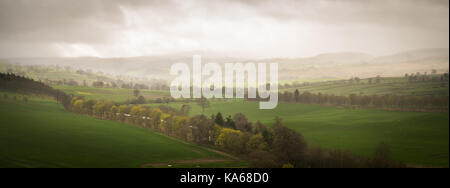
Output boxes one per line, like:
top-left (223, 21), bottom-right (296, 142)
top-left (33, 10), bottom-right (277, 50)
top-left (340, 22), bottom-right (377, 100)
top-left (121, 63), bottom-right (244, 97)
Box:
top-left (146, 100), bottom-right (449, 167)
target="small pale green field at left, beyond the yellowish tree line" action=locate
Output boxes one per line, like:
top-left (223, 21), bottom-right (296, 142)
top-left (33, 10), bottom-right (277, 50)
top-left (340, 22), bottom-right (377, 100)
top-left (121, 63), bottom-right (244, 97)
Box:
top-left (53, 86), bottom-right (170, 102)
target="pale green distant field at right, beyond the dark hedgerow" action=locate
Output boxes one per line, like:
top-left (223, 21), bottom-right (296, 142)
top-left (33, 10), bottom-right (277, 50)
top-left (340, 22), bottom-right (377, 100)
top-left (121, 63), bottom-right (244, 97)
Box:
top-left (280, 78), bottom-right (449, 96)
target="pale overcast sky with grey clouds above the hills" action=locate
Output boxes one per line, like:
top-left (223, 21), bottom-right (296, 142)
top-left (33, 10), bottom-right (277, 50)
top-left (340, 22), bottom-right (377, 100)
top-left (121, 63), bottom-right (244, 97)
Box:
top-left (0, 0), bottom-right (449, 58)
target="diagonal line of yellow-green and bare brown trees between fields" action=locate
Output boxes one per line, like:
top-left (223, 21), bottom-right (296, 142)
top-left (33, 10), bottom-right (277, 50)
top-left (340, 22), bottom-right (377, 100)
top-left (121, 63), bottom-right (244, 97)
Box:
top-left (0, 74), bottom-right (405, 168)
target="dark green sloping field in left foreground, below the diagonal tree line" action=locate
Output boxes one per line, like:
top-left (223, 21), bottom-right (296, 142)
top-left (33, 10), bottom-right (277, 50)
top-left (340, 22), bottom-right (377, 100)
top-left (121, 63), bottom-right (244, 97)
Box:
top-left (0, 93), bottom-right (241, 167)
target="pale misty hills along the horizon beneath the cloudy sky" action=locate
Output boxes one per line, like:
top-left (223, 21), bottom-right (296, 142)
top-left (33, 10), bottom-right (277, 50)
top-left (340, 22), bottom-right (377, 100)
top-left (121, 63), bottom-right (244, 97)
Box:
top-left (0, 49), bottom-right (449, 80)
